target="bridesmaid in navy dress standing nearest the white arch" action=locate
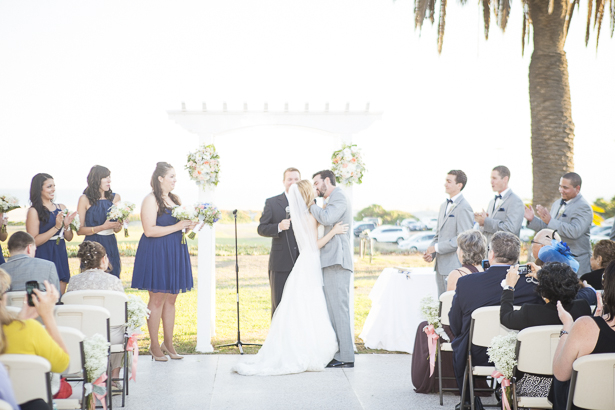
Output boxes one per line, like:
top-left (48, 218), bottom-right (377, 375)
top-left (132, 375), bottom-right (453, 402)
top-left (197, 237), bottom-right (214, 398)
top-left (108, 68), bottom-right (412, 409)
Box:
top-left (132, 162), bottom-right (196, 362)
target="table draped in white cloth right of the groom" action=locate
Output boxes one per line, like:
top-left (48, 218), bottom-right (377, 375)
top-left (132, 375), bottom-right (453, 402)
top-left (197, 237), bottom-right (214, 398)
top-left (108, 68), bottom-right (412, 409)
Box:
top-left (359, 268), bottom-right (438, 353)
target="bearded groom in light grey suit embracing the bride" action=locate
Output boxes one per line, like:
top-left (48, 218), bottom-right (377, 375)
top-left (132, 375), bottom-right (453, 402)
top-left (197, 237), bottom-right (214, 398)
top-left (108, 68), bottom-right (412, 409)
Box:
top-left (310, 170), bottom-right (354, 368)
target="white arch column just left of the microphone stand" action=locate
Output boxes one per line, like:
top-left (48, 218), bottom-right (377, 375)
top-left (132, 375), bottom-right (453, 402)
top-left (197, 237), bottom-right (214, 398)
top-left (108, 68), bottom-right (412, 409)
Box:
top-left (196, 135), bottom-right (216, 353)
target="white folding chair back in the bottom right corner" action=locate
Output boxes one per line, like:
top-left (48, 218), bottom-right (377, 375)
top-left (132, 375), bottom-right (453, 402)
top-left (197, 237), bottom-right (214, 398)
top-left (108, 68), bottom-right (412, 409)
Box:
top-left (566, 353), bottom-right (615, 410)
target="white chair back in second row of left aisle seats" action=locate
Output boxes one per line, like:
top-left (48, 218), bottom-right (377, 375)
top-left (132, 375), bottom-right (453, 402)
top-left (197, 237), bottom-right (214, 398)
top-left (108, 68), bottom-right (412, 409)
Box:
top-left (54, 305), bottom-right (111, 341)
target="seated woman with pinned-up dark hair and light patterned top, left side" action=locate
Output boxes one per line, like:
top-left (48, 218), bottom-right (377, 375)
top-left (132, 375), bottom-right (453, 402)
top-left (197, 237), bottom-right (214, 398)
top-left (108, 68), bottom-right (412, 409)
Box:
top-left (66, 241), bottom-right (126, 388)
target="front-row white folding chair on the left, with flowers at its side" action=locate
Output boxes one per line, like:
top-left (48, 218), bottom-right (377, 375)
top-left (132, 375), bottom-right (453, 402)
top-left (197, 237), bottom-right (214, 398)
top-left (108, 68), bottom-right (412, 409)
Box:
top-left (62, 290), bottom-right (128, 407)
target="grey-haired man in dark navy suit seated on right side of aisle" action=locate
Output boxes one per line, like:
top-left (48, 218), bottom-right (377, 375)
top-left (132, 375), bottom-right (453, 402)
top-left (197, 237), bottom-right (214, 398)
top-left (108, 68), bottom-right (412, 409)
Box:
top-left (448, 232), bottom-right (544, 406)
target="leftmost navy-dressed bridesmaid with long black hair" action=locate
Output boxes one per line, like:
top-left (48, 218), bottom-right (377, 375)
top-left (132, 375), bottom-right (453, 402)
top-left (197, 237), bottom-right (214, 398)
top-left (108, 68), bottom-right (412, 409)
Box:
top-left (26, 173), bottom-right (77, 294)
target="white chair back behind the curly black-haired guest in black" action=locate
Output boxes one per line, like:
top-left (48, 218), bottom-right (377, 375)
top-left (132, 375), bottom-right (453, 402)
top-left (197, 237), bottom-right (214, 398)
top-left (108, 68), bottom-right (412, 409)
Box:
top-left (517, 325), bottom-right (562, 376)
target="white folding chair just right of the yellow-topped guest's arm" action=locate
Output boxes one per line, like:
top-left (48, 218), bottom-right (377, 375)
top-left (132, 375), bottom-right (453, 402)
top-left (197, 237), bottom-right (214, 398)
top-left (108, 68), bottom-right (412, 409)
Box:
top-left (54, 326), bottom-right (87, 410)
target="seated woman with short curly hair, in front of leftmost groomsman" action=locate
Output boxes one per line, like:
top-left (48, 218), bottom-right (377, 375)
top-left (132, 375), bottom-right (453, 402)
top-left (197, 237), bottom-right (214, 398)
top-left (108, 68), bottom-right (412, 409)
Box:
top-left (446, 229), bottom-right (487, 291)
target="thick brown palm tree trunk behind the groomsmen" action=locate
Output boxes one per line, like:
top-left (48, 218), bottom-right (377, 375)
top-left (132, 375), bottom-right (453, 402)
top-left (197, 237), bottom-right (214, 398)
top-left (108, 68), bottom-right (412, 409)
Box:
top-left (529, 0), bottom-right (574, 208)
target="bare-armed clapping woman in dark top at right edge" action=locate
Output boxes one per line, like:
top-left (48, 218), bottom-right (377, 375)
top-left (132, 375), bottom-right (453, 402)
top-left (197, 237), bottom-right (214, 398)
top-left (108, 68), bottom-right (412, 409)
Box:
top-left (549, 261), bottom-right (615, 410)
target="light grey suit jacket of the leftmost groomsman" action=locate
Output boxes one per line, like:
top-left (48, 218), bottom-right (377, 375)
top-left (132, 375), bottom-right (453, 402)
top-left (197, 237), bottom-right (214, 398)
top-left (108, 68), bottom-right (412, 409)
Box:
top-left (431, 195), bottom-right (474, 276)
